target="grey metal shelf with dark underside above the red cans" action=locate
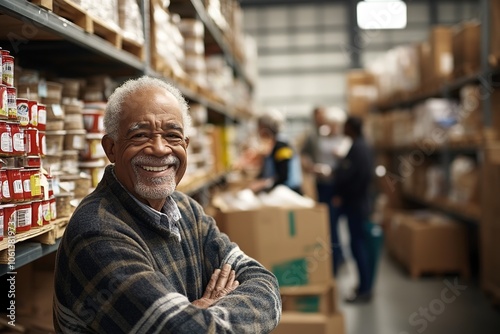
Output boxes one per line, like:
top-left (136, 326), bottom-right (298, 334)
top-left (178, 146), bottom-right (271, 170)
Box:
top-left (0, 0), bottom-right (145, 75)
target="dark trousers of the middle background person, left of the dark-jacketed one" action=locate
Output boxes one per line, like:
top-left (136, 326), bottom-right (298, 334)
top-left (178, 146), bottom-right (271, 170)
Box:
top-left (316, 182), bottom-right (344, 275)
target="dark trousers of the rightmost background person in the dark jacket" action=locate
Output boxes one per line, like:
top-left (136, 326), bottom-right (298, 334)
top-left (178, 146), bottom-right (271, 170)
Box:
top-left (330, 205), bottom-right (372, 294)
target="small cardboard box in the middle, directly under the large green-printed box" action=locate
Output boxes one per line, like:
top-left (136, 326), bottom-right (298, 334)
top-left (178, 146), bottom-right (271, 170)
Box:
top-left (280, 280), bottom-right (337, 315)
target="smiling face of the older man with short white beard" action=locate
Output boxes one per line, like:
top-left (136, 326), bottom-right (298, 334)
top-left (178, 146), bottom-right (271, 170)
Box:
top-left (103, 88), bottom-right (189, 209)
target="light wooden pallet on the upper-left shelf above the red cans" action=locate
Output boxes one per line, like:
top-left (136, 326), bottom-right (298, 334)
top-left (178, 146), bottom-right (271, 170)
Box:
top-left (31, 0), bottom-right (145, 60)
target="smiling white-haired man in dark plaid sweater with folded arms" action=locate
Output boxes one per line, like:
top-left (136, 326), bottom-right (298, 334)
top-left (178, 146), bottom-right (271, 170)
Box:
top-left (54, 77), bottom-right (281, 334)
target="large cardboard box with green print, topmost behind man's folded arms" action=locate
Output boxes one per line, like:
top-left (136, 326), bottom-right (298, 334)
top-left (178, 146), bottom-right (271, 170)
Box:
top-left (215, 204), bottom-right (333, 286)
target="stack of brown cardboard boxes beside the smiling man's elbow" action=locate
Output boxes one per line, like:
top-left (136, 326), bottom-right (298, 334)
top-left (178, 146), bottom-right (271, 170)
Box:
top-left (216, 204), bottom-right (345, 334)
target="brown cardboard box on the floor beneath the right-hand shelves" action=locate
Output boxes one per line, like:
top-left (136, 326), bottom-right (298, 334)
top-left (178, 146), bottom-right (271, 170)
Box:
top-left (389, 211), bottom-right (470, 279)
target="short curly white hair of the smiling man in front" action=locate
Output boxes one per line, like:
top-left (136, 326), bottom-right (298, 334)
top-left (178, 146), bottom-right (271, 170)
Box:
top-left (104, 76), bottom-right (191, 140)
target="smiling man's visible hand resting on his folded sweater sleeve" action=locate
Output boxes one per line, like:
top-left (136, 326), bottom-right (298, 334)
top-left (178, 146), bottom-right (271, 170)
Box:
top-left (192, 264), bottom-right (240, 308)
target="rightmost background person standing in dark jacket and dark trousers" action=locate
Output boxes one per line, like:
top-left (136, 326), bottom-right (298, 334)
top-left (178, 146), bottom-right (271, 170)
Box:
top-left (332, 116), bottom-right (373, 302)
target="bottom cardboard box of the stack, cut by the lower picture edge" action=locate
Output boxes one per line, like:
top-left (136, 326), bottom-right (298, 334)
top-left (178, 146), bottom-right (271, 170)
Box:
top-left (272, 312), bottom-right (345, 334)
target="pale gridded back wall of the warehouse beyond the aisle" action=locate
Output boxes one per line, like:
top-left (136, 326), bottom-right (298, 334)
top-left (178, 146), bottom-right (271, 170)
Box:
top-left (242, 1), bottom-right (479, 138)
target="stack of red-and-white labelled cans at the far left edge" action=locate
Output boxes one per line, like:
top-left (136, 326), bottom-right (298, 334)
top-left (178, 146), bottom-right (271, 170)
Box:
top-left (0, 50), bottom-right (56, 240)
